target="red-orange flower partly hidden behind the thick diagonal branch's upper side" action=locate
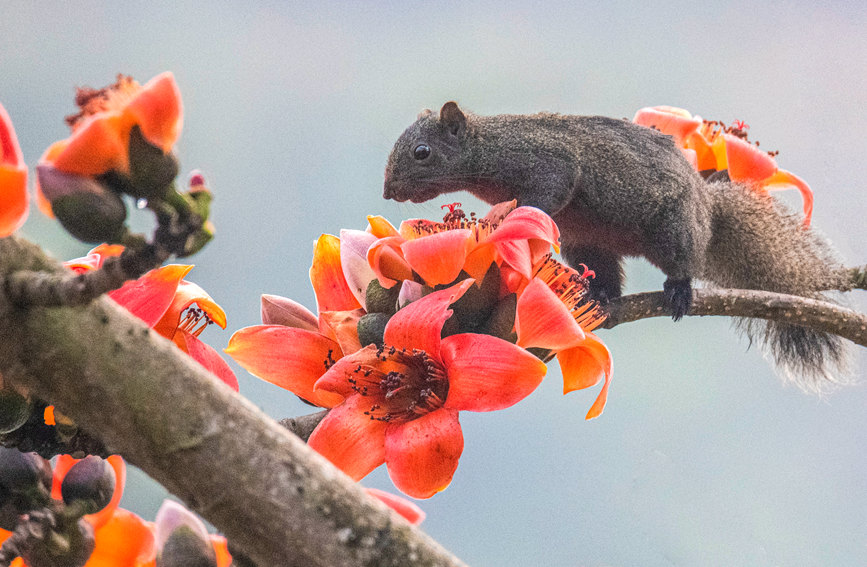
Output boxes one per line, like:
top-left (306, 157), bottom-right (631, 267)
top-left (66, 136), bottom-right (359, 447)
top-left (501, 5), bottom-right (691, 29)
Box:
top-left (65, 245), bottom-right (238, 392)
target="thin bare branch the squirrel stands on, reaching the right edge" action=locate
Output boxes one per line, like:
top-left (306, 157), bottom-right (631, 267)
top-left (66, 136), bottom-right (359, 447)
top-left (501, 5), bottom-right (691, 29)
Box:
top-left (603, 289), bottom-right (867, 346)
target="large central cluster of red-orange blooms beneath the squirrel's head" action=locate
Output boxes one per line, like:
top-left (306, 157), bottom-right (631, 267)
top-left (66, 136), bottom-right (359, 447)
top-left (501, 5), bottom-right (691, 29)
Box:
top-left (226, 202), bottom-right (611, 498)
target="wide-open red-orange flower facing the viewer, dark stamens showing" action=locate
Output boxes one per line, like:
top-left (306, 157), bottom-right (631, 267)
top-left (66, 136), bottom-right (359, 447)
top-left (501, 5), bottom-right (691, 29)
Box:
top-left (308, 280), bottom-right (545, 498)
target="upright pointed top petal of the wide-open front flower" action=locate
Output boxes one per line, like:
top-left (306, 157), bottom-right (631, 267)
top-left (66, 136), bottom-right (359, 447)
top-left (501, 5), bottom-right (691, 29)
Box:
top-left (384, 279), bottom-right (475, 357)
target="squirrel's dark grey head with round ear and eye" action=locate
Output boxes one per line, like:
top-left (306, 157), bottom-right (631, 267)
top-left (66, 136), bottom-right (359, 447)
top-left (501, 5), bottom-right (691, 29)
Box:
top-left (383, 102), bottom-right (467, 203)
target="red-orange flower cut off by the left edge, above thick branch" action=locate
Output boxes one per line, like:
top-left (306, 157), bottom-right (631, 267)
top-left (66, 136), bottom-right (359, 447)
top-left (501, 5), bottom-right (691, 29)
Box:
top-left (0, 104), bottom-right (30, 237)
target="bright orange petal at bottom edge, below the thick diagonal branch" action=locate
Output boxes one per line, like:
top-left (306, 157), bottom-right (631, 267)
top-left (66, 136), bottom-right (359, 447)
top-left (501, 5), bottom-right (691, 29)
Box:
top-left (84, 508), bottom-right (156, 567)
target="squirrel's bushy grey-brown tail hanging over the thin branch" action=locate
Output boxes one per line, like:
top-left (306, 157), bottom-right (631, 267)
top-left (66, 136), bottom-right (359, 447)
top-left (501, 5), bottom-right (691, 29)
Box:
top-left (704, 182), bottom-right (849, 390)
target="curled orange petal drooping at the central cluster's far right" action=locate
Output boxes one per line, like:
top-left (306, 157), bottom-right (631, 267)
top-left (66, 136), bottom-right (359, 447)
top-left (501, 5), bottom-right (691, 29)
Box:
top-left (557, 333), bottom-right (612, 419)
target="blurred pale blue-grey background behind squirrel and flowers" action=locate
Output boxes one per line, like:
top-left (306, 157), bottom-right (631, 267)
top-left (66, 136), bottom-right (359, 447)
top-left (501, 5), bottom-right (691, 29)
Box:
top-left (0, 0), bottom-right (867, 567)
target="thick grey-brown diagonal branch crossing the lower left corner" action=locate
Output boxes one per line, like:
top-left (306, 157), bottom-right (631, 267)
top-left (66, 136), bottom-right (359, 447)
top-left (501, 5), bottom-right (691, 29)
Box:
top-left (0, 238), bottom-right (463, 567)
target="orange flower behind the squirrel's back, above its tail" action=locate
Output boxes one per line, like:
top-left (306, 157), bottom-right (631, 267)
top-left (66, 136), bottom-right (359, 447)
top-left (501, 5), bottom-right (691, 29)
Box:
top-left (632, 106), bottom-right (813, 225)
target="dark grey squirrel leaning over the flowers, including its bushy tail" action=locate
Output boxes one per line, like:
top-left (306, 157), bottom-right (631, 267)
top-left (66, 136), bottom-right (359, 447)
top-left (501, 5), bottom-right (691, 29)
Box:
top-left (383, 102), bottom-right (847, 388)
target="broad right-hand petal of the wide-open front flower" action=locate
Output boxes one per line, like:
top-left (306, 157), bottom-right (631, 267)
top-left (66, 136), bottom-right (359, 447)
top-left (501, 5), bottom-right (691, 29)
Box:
top-left (440, 333), bottom-right (547, 411)
